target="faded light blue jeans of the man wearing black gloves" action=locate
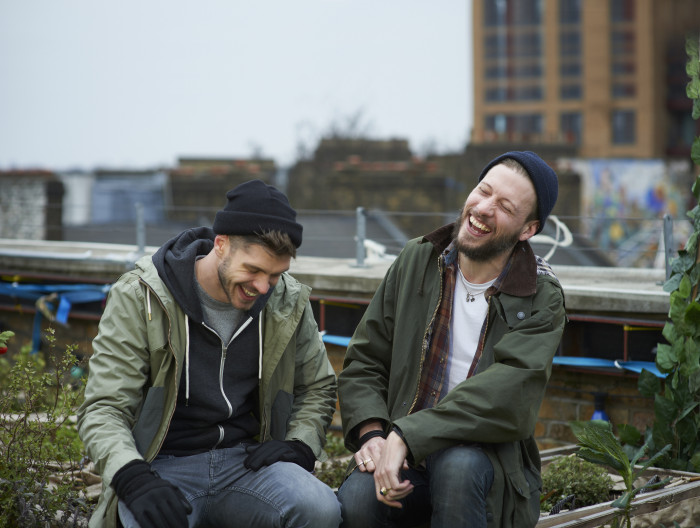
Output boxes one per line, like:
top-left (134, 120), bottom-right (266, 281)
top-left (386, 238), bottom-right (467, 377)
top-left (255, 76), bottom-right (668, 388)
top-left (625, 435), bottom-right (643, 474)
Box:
top-left (119, 446), bottom-right (340, 528)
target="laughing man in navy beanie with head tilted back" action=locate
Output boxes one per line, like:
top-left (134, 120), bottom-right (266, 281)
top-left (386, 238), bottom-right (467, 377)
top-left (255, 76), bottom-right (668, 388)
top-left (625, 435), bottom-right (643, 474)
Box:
top-left (338, 151), bottom-right (566, 528)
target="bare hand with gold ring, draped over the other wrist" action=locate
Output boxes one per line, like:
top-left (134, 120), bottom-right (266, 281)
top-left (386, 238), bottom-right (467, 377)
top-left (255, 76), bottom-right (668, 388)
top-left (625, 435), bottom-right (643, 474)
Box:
top-left (374, 432), bottom-right (413, 508)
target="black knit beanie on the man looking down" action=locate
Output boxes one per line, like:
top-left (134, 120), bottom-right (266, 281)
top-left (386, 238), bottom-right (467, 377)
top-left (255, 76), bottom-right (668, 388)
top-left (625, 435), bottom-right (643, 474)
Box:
top-left (212, 180), bottom-right (303, 248)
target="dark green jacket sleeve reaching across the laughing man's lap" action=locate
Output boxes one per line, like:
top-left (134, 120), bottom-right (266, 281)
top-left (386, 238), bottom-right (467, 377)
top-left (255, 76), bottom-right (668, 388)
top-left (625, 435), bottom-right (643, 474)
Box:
top-left (395, 283), bottom-right (566, 463)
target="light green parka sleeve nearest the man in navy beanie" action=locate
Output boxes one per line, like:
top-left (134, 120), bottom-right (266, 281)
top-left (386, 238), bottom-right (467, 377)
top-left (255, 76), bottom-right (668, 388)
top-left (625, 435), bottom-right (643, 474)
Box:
top-left (286, 301), bottom-right (337, 458)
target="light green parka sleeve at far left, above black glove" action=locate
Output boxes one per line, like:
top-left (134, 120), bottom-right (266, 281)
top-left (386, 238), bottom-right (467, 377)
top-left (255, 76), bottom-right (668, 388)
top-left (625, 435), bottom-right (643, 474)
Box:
top-left (78, 277), bottom-right (149, 484)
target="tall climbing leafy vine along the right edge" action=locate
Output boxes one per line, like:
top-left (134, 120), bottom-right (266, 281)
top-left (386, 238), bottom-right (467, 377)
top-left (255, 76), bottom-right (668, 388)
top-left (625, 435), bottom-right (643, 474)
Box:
top-left (639, 31), bottom-right (700, 472)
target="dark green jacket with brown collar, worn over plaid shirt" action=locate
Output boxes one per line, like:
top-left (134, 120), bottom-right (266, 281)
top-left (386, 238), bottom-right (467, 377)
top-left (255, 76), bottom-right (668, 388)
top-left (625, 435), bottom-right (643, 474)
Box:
top-left (338, 225), bottom-right (566, 528)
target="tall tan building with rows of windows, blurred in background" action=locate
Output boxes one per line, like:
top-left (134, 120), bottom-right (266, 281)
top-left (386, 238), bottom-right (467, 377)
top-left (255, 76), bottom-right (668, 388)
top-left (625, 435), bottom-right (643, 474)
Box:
top-left (471, 0), bottom-right (700, 158)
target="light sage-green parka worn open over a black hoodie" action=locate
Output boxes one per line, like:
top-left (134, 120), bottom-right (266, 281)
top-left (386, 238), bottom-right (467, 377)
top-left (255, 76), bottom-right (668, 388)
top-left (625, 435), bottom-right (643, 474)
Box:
top-left (78, 257), bottom-right (336, 528)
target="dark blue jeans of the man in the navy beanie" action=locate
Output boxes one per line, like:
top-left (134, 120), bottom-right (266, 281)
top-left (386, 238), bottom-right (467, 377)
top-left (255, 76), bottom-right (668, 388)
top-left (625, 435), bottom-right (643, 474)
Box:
top-left (338, 446), bottom-right (493, 528)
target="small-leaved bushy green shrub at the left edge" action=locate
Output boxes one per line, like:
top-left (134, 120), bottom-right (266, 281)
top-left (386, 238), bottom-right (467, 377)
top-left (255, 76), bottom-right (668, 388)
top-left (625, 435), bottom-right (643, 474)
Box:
top-left (0, 331), bottom-right (92, 528)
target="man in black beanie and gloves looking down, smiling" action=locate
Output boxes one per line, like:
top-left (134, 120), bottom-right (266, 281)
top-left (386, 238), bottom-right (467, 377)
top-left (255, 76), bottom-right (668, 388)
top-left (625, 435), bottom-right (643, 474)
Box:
top-left (78, 180), bottom-right (340, 528)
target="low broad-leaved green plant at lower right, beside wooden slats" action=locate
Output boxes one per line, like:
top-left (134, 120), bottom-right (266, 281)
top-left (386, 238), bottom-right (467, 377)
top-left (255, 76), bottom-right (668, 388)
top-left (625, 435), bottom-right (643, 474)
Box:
top-left (570, 420), bottom-right (671, 528)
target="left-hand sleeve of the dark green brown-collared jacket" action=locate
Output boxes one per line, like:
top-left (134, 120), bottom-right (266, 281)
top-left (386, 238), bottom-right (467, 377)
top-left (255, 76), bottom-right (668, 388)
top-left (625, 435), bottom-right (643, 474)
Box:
top-left (338, 257), bottom-right (401, 451)
